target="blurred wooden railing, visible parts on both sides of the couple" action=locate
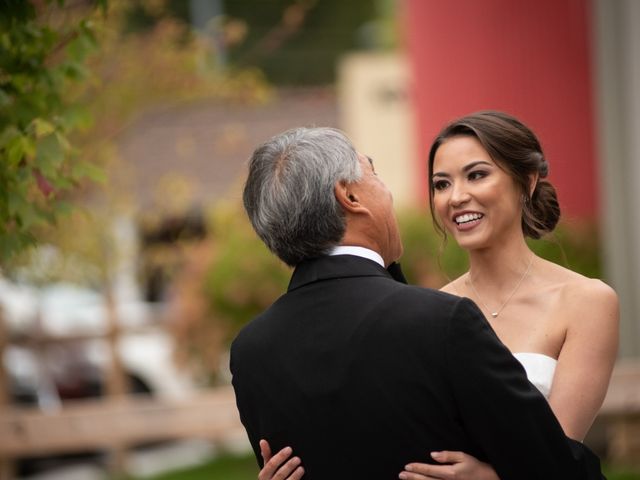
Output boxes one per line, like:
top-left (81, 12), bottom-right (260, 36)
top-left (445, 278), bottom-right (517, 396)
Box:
top-left (0, 361), bottom-right (640, 476)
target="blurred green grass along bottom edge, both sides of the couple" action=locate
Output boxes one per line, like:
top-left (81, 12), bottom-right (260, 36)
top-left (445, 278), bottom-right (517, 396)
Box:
top-left (132, 455), bottom-right (640, 480)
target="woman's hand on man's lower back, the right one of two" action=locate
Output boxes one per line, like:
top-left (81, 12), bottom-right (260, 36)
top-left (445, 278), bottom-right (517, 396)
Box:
top-left (398, 452), bottom-right (500, 480)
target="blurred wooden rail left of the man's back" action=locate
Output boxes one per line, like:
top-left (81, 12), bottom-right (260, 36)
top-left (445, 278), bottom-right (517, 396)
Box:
top-left (0, 387), bottom-right (244, 457)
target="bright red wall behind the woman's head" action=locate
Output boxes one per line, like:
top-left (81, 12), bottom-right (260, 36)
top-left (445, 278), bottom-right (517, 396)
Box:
top-left (403, 0), bottom-right (598, 218)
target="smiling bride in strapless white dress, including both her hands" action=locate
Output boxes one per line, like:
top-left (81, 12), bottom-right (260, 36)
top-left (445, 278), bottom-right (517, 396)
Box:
top-left (258, 111), bottom-right (619, 480)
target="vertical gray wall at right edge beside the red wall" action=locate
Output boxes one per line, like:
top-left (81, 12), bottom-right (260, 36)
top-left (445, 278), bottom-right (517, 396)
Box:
top-left (592, 0), bottom-right (640, 357)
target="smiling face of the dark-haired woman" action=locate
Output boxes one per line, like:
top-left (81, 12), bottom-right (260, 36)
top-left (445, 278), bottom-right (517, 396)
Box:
top-left (431, 136), bottom-right (522, 250)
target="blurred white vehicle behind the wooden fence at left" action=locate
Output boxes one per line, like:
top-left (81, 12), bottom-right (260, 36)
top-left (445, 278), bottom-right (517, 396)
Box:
top-left (0, 278), bottom-right (195, 409)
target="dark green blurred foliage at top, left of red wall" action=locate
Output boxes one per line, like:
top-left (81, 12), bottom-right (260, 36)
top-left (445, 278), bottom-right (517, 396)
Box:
top-left (225, 0), bottom-right (393, 85)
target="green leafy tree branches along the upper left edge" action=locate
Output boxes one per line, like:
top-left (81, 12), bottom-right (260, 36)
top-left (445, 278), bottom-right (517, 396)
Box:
top-left (0, 0), bottom-right (106, 261)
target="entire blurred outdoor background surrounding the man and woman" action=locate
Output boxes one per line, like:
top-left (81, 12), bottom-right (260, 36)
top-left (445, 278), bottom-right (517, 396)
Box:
top-left (0, 0), bottom-right (640, 480)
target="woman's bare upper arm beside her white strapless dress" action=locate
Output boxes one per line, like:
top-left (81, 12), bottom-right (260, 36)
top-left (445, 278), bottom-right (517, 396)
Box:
top-left (549, 280), bottom-right (619, 441)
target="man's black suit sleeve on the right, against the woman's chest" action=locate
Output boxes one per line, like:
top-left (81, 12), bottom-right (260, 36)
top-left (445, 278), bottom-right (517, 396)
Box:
top-left (447, 299), bottom-right (603, 480)
